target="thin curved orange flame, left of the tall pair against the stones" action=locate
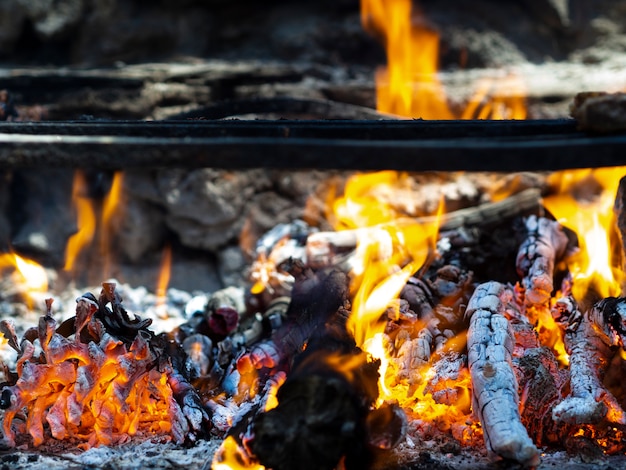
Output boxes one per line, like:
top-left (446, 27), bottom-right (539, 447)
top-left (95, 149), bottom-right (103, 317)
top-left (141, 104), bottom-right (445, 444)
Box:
top-left (63, 171), bottom-right (96, 271)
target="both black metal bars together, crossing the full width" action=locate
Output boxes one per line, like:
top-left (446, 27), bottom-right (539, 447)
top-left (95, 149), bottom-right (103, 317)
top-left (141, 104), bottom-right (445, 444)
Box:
top-left (0, 120), bottom-right (626, 171)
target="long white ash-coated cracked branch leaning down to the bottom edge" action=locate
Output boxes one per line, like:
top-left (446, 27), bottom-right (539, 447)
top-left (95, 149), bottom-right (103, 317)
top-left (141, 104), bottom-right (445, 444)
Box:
top-left (466, 282), bottom-right (540, 465)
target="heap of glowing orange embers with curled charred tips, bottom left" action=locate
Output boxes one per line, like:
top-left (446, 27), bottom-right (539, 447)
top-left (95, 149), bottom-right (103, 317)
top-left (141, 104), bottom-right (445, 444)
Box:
top-left (0, 283), bottom-right (208, 447)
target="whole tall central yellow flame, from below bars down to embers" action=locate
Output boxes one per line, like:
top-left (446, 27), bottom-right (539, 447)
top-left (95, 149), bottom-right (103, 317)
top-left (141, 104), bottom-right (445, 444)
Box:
top-left (324, 171), bottom-right (476, 432)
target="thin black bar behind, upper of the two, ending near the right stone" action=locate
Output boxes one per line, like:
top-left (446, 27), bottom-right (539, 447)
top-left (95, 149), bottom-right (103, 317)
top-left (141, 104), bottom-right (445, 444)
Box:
top-left (0, 119), bottom-right (582, 140)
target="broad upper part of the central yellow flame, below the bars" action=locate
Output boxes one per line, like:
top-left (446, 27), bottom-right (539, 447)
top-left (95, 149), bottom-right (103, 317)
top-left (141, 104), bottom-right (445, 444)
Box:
top-left (331, 171), bottom-right (443, 346)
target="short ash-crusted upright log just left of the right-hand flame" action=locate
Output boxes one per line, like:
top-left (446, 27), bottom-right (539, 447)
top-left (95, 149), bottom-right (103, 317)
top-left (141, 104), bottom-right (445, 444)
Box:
top-left (516, 215), bottom-right (568, 305)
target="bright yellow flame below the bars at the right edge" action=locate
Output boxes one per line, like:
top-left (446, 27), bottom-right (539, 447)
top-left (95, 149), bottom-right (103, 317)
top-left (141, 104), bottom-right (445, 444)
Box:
top-left (543, 167), bottom-right (626, 302)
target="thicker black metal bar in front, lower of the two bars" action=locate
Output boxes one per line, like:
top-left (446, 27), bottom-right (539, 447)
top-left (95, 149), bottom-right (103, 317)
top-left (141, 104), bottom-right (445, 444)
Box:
top-left (0, 121), bottom-right (626, 171)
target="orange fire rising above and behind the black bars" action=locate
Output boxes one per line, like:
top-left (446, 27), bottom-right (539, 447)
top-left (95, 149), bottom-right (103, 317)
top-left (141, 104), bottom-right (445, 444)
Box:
top-left (361, 0), bottom-right (526, 119)
